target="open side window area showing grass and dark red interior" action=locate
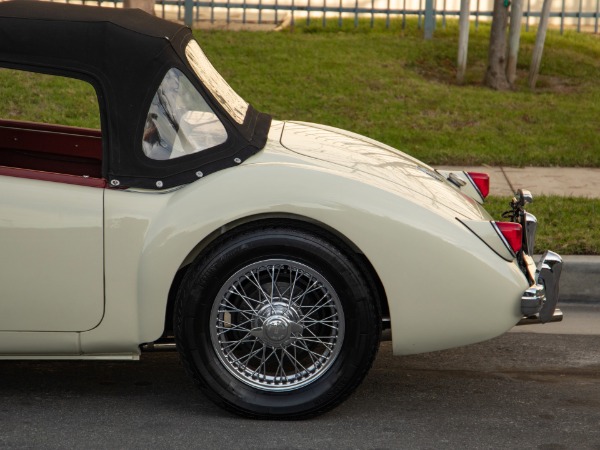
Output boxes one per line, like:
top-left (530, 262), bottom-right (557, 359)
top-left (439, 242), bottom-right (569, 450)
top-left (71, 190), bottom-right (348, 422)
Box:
top-left (0, 68), bottom-right (102, 178)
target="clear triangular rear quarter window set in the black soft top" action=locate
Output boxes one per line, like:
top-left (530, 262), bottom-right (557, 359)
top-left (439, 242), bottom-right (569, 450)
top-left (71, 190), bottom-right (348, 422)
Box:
top-left (142, 69), bottom-right (227, 160)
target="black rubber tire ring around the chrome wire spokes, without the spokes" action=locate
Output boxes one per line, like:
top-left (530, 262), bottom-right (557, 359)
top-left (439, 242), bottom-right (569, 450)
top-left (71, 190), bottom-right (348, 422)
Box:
top-left (178, 229), bottom-right (379, 417)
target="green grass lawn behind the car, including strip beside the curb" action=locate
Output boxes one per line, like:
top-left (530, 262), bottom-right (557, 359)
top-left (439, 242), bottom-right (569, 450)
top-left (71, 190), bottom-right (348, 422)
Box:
top-left (0, 21), bottom-right (600, 254)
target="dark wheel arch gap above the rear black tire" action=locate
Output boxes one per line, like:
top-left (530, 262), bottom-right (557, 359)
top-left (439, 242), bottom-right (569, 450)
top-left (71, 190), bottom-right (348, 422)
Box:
top-left (163, 213), bottom-right (390, 336)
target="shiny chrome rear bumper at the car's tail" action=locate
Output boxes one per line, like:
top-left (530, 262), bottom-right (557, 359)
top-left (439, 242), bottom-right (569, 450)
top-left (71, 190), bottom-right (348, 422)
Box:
top-left (519, 250), bottom-right (563, 325)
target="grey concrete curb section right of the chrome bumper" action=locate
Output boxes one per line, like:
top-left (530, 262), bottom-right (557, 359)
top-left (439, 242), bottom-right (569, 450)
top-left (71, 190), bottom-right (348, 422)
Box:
top-left (558, 255), bottom-right (600, 305)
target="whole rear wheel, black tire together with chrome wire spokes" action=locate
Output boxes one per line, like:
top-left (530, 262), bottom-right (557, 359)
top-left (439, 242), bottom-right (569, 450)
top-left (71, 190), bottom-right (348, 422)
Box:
top-left (174, 226), bottom-right (381, 419)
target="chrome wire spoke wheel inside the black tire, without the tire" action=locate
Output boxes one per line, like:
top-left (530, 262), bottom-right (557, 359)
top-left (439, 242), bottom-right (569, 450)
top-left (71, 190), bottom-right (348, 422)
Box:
top-left (211, 259), bottom-right (344, 391)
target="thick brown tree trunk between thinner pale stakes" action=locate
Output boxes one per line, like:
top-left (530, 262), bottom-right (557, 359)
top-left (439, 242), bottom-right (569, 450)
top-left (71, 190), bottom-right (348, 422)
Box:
top-left (483, 0), bottom-right (510, 90)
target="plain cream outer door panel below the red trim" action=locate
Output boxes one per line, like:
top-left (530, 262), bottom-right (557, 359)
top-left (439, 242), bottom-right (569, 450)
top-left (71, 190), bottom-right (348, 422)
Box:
top-left (0, 176), bottom-right (104, 332)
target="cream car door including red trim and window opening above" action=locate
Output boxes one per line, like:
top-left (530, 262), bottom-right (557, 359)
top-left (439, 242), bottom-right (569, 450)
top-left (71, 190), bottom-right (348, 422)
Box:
top-left (0, 69), bottom-right (105, 332)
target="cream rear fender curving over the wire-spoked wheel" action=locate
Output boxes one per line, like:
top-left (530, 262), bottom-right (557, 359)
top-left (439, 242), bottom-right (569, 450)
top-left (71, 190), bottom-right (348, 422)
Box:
top-left (72, 122), bottom-right (527, 354)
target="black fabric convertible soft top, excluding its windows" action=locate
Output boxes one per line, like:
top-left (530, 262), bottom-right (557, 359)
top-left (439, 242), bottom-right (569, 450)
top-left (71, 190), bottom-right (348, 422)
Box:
top-left (0, 0), bottom-right (271, 189)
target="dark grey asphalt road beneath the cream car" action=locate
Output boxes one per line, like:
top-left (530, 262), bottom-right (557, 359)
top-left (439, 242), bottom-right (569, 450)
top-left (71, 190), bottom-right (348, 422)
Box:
top-left (0, 305), bottom-right (600, 450)
